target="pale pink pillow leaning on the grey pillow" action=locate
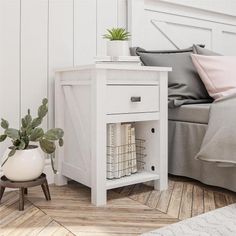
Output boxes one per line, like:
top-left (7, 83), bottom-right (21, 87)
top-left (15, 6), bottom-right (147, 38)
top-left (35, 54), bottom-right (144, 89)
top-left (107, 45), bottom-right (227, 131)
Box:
top-left (191, 54), bottom-right (236, 99)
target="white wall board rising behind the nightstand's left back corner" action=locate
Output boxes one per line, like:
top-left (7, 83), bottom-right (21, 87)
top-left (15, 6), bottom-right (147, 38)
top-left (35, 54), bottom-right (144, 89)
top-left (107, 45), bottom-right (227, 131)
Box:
top-left (47, 0), bottom-right (75, 131)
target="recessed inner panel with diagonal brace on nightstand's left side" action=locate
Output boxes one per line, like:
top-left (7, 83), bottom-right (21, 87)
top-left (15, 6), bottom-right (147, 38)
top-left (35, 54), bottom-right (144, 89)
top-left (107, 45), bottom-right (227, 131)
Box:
top-left (62, 84), bottom-right (91, 186)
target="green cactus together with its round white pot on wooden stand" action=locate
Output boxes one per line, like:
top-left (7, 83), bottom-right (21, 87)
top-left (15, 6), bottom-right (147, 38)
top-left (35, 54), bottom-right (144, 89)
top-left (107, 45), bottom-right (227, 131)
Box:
top-left (0, 98), bottom-right (64, 181)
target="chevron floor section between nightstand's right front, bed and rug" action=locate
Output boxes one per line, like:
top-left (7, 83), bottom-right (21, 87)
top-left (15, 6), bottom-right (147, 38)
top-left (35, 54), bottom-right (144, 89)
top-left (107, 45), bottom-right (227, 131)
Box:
top-left (115, 176), bottom-right (236, 220)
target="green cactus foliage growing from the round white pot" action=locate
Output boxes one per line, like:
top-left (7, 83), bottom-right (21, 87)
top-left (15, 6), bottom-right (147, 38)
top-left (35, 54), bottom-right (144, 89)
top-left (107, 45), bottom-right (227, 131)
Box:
top-left (0, 98), bottom-right (64, 169)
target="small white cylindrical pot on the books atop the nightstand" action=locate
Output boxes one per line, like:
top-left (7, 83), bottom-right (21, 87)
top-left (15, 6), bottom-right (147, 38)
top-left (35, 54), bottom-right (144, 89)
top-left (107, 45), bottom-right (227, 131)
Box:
top-left (107, 40), bottom-right (130, 57)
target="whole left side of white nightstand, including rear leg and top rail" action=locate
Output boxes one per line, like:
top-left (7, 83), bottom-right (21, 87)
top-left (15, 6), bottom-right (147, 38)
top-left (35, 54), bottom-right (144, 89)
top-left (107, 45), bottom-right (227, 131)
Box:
top-left (55, 70), bottom-right (92, 186)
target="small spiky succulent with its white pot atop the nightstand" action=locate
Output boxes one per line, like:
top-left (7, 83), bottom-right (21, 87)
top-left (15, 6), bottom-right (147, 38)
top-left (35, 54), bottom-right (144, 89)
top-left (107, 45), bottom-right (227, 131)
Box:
top-left (103, 28), bottom-right (131, 56)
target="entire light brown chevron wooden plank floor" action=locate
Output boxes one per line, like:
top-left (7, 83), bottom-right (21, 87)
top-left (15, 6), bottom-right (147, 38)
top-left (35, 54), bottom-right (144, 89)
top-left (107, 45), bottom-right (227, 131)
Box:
top-left (0, 178), bottom-right (236, 236)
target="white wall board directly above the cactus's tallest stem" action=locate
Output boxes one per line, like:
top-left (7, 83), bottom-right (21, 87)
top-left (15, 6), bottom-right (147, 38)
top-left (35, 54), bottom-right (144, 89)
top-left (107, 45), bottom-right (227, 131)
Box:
top-left (20, 0), bottom-right (48, 120)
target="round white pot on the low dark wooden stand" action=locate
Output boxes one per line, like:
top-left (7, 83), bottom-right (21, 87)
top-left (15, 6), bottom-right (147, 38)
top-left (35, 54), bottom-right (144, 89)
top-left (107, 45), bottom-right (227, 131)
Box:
top-left (2, 146), bottom-right (45, 181)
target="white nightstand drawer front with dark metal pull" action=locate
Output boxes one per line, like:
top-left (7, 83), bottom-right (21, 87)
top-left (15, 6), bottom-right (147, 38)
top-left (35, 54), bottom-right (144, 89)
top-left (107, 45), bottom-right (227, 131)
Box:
top-left (107, 85), bottom-right (159, 114)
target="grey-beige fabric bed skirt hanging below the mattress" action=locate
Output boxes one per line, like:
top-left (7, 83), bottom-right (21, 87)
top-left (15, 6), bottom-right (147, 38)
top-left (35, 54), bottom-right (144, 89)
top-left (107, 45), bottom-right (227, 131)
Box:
top-left (168, 121), bottom-right (236, 192)
